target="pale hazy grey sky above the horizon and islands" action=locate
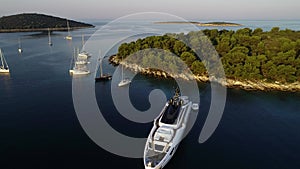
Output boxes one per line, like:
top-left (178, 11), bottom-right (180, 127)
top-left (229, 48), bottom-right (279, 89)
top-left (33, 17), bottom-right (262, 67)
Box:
top-left (0, 0), bottom-right (300, 20)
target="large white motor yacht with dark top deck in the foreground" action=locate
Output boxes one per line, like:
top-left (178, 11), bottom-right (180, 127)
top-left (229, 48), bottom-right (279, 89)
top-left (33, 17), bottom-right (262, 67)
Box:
top-left (144, 89), bottom-right (192, 169)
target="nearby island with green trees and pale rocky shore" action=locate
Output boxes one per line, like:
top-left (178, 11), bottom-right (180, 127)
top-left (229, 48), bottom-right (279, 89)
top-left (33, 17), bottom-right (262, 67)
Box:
top-left (110, 27), bottom-right (300, 91)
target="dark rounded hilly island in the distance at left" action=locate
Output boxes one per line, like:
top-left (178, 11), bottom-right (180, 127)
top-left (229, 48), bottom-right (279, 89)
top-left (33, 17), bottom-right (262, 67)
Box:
top-left (0, 13), bottom-right (94, 33)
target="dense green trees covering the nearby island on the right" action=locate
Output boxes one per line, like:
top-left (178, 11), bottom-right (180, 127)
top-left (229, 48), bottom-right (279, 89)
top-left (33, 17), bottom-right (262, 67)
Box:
top-left (117, 27), bottom-right (300, 83)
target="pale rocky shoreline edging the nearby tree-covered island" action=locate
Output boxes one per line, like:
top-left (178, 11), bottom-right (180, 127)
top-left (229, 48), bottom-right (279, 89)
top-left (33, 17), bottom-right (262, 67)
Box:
top-left (109, 56), bottom-right (300, 92)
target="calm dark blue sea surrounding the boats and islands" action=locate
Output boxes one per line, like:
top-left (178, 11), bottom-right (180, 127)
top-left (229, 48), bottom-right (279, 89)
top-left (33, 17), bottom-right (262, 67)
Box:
top-left (0, 21), bottom-right (300, 169)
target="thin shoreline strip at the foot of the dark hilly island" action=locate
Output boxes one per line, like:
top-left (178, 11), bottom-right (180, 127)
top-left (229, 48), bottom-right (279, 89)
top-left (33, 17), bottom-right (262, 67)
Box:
top-left (0, 26), bottom-right (94, 33)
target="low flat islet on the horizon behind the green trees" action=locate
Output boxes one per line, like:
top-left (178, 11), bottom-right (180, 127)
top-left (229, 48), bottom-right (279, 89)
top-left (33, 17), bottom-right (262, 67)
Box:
top-left (154, 21), bottom-right (243, 26)
